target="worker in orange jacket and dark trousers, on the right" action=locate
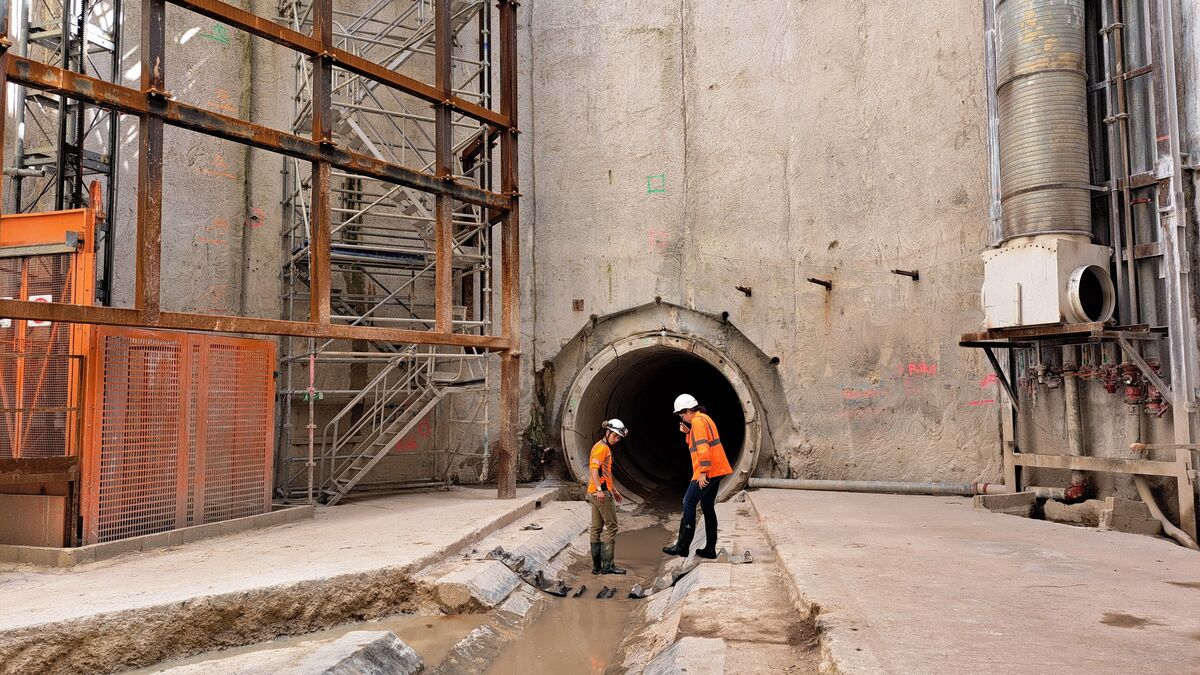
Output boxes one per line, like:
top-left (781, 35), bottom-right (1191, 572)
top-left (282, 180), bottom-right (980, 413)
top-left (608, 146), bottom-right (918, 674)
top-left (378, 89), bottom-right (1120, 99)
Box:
top-left (662, 394), bottom-right (733, 558)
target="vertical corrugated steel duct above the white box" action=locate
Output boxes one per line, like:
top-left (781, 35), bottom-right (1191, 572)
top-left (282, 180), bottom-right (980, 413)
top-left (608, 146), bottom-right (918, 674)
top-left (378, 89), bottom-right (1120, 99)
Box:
top-left (996, 0), bottom-right (1092, 243)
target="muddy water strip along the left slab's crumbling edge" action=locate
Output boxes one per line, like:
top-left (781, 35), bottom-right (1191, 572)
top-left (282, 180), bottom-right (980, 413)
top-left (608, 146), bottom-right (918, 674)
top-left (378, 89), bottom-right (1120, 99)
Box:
top-left (130, 614), bottom-right (486, 674)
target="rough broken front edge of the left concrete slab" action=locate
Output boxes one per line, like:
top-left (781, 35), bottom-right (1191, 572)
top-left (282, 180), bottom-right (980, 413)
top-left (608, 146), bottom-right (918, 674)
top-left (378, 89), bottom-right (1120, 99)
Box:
top-left (0, 485), bottom-right (558, 674)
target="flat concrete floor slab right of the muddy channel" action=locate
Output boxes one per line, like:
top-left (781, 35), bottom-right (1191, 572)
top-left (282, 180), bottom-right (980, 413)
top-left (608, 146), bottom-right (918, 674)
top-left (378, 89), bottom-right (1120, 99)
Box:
top-left (750, 490), bottom-right (1200, 674)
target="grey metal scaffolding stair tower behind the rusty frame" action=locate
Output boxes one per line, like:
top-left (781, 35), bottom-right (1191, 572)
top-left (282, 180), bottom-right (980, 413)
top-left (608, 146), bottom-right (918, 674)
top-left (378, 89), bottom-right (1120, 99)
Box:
top-left (277, 0), bottom-right (497, 503)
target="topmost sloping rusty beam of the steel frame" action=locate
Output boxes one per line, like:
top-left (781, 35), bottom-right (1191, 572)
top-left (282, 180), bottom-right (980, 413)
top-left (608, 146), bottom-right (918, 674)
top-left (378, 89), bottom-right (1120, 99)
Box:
top-left (170, 0), bottom-right (512, 129)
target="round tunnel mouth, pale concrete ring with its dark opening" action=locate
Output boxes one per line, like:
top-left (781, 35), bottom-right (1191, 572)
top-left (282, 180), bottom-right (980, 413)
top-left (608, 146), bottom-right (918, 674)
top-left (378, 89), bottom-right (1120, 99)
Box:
top-left (562, 333), bottom-right (760, 500)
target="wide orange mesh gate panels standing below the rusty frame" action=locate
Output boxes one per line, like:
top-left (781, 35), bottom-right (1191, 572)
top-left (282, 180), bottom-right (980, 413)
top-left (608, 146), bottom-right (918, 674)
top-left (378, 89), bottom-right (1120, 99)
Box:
top-left (84, 327), bottom-right (275, 543)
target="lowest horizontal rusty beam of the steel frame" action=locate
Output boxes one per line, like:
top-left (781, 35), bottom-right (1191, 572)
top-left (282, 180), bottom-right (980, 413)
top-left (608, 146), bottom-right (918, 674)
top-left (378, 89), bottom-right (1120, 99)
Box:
top-left (0, 299), bottom-right (509, 352)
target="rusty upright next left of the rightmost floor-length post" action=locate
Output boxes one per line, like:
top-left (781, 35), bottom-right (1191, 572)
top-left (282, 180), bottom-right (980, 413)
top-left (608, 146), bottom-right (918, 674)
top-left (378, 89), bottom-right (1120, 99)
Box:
top-left (433, 0), bottom-right (454, 331)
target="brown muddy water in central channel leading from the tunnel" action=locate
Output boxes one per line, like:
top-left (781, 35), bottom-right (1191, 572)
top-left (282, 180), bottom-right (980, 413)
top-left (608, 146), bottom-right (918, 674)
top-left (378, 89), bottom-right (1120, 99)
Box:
top-left (487, 527), bottom-right (671, 675)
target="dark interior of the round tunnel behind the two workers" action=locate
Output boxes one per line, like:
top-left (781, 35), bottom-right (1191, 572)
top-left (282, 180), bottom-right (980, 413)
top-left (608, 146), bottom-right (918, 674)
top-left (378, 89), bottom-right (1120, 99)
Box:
top-left (575, 347), bottom-right (745, 498)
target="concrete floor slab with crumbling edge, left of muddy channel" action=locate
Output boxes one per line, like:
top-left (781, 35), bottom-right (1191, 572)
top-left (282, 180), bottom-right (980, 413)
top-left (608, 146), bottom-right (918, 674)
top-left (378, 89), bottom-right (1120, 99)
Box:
top-left (0, 488), bottom-right (557, 673)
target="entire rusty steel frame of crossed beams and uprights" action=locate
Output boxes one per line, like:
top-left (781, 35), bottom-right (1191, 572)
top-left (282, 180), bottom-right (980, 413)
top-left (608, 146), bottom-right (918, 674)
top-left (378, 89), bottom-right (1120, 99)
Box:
top-left (0, 0), bottom-right (520, 498)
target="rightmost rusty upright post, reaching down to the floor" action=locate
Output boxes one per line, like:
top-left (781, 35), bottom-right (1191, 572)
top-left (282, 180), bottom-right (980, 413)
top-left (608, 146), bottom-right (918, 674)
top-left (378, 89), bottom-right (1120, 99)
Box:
top-left (496, 0), bottom-right (521, 498)
